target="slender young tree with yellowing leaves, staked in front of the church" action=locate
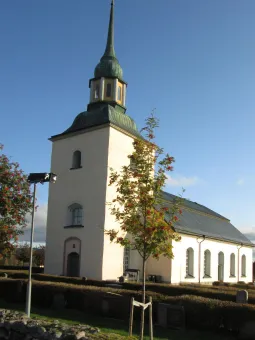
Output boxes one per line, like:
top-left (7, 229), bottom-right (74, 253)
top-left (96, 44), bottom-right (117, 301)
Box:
top-left (106, 114), bottom-right (182, 339)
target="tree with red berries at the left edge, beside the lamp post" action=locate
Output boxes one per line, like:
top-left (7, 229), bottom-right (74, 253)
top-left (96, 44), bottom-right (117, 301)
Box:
top-left (0, 145), bottom-right (33, 258)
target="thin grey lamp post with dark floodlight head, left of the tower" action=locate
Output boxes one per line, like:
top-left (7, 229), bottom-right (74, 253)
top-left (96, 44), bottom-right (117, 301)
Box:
top-left (26, 172), bottom-right (57, 318)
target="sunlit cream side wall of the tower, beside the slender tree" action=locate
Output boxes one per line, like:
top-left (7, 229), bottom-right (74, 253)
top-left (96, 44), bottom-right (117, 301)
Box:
top-left (103, 127), bottom-right (136, 280)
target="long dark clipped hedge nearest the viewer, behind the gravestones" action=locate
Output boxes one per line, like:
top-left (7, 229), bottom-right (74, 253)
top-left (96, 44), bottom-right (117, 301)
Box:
top-left (0, 279), bottom-right (255, 331)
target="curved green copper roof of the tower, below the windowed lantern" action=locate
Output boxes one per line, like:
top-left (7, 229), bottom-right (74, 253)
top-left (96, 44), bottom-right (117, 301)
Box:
top-left (51, 103), bottom-right (141, 140)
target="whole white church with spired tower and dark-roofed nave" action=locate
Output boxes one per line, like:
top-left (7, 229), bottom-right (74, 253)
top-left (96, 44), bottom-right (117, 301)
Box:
top-left (45, 3), bottom-right (254, 284)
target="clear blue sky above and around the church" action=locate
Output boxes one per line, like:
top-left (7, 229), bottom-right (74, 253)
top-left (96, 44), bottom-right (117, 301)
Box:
top-left (0, 0), bottom-right (255, 244)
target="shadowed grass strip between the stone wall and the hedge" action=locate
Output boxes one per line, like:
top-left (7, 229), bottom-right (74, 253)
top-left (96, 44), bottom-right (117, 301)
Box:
top-left (0, 300), bottom-right (234, 340)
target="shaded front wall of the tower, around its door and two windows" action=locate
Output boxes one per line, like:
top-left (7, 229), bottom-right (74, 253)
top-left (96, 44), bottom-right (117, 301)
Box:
top-left (45, 127), bottom-right (109, 279)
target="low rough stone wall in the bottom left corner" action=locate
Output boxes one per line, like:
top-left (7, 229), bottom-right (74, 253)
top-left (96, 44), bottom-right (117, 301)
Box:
top-left (0, 310), bottom-right (99, 340)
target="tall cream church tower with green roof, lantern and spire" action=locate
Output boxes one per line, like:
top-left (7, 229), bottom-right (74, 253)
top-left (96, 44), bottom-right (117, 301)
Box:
top-left (45, 1), bottom-right (139, 280)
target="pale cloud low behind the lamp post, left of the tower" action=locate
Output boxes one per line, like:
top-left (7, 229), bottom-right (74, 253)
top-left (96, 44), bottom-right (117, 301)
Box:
top-left (19, 203), bottom-right (48, 242)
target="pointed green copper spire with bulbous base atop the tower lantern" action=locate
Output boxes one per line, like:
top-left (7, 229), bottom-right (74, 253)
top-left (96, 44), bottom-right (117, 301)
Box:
top-left (94, 0), bottom-right (123, 80)
